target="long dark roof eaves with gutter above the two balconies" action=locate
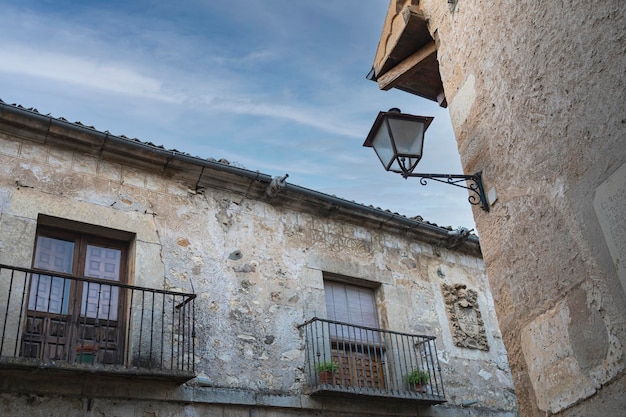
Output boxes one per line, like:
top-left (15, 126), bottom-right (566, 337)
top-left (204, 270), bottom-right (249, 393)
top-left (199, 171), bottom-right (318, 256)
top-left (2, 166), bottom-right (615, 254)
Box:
top-left (0, 100), bottom-right (481, 256)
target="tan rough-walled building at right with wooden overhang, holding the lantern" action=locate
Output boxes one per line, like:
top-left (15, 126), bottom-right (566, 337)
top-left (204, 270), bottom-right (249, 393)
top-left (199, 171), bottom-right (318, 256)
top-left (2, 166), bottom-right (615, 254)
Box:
top-left (369, 0), bottom-right (626, 416)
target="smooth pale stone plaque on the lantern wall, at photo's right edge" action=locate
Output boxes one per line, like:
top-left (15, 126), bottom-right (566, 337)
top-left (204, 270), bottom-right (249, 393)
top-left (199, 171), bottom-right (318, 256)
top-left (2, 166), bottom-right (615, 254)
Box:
top-left (593, 164), bottom-right (626, 291)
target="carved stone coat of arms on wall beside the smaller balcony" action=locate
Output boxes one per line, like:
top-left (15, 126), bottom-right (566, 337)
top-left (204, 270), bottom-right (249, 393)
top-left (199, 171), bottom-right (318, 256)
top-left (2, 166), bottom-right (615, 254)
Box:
top-left (441, 284), bottom-right (489, 350)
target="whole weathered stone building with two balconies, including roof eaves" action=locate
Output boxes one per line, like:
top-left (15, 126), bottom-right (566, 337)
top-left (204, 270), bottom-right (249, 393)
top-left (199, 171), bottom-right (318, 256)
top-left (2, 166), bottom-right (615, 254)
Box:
top-left (0, 103), bottom-right (517, 417)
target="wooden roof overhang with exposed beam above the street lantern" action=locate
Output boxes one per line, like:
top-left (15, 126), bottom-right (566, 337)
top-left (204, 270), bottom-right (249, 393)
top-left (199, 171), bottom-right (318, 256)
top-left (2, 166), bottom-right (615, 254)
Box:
top-left (367, 0), bottom-right (447, 107)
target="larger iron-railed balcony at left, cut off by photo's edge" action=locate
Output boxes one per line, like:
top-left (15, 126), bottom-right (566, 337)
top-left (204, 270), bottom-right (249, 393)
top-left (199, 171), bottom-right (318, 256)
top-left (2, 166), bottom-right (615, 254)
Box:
top-left (0, 264), bottom-right (196, 382)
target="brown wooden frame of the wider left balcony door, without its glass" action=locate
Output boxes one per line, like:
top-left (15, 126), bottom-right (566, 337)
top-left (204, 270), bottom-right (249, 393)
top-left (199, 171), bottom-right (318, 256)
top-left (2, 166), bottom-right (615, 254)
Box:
top-left (21, 219), bottom-right (134, 363)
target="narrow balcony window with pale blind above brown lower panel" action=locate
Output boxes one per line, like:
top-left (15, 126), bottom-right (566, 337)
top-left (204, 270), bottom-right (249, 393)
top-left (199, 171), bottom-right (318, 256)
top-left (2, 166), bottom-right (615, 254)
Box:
top-left (324, 281), bottom-right (385, 388)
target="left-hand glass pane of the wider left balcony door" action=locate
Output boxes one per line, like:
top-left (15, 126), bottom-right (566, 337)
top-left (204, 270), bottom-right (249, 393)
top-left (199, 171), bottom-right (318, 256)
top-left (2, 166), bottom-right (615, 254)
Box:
top-left (28, 236), bottom-right (74, 314)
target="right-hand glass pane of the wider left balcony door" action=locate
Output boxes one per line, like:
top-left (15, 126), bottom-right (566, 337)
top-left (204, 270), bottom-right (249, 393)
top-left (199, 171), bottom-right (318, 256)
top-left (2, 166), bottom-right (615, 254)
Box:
top-left (80, 245), bottom-right (122, 320)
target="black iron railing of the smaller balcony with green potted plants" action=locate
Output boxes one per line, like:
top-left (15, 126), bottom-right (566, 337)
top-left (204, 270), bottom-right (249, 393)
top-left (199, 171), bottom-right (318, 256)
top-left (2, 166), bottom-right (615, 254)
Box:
top-left (299, 318), bottom-right (446, 404)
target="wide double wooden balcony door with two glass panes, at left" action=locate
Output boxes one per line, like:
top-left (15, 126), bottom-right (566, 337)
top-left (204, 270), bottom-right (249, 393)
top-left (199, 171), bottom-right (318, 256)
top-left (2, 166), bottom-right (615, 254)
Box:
top-left (21, 226), bottom-right (128, 363)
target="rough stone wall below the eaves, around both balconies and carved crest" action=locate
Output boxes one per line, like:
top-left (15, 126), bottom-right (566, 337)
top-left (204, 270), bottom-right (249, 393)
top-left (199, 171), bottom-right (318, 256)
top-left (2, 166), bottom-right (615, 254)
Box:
top-left (0, 122), bottom-right (516, 416)
